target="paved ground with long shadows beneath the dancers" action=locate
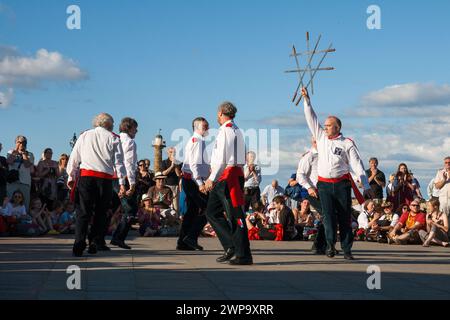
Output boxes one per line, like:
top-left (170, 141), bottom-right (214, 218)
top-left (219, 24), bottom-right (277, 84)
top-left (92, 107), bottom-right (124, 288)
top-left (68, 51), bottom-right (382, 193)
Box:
top-left (0, 232), bottom-right (450, 300)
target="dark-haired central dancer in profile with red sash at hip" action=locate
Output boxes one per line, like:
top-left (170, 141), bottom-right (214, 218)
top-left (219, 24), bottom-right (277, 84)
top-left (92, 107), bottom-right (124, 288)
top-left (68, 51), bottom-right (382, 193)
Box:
top-left (205, 102), bottom-right (253, 265)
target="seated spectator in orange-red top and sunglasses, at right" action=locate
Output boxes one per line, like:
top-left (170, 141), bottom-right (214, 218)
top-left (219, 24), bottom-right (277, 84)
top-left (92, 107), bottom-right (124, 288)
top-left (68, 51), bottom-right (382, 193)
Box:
top-left (388, 199), bottom-right (426, 244)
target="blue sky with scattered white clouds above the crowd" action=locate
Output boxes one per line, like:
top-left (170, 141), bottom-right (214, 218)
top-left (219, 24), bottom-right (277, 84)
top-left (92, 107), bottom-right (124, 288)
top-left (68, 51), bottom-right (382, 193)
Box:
top-left (0, 0), bottom-right (450, 195)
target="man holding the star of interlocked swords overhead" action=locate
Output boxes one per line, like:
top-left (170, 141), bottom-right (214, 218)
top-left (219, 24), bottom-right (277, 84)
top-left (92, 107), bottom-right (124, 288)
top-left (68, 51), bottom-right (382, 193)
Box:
top-left (302, 88), bottom-right (373, 260)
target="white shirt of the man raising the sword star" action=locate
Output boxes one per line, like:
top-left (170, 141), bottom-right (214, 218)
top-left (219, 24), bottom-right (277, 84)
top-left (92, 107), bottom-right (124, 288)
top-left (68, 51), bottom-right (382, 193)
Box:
top-left (304, 99), bottom-right (370, 190)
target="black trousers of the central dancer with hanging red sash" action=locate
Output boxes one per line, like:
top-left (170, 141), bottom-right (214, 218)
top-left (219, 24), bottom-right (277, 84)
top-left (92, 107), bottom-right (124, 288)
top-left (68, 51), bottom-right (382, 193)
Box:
top-left (206, 177), bottom-right (251, 258)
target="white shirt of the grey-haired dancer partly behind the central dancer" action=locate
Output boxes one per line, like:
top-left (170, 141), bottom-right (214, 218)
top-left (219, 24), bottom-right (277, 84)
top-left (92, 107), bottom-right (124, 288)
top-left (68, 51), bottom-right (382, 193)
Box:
top-left (181, 132), bottom-right (211, 186)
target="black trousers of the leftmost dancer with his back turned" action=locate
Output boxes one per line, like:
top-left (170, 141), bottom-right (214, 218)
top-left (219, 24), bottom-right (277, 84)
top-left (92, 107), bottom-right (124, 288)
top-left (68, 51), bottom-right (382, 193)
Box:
top-left (75, 177), bottom-right (113, 245)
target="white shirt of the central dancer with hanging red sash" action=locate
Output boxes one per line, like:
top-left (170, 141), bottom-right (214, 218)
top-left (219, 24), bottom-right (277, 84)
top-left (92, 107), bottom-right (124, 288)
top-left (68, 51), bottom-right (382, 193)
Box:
top-left (208, 120), bottom-right (245, 182)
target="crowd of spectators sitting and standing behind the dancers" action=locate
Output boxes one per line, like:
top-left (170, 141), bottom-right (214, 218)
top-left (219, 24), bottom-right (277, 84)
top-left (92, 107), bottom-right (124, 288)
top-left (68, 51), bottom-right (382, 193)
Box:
top-left (0, 136), bottom-right (450, 247)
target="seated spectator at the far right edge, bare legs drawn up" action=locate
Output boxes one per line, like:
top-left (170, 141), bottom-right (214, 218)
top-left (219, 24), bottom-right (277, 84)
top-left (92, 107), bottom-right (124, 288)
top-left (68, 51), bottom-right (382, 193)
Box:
top-left (419, 199), bottom-right (449, 247)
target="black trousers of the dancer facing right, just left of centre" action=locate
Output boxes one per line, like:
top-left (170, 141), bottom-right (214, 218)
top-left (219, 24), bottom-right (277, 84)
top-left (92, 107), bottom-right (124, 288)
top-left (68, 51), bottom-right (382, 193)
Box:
top-left (178, 178), bottom-right (208, 245)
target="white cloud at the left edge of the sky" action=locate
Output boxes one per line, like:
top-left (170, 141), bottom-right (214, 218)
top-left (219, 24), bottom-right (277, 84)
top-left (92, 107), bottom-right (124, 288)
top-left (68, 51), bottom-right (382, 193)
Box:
top-left (0, 46), bottom-right (88, 107)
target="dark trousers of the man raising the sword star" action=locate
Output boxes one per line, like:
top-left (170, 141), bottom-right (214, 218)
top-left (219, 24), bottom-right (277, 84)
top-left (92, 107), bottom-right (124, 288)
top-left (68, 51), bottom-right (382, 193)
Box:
top-left (317, 180), bottom-right (353, 253)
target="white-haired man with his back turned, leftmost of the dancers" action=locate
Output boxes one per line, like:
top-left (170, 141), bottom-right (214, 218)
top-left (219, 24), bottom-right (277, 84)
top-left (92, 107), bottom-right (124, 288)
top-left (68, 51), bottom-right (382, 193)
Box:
top-left (67, 113), bottom-right (126, 257)
